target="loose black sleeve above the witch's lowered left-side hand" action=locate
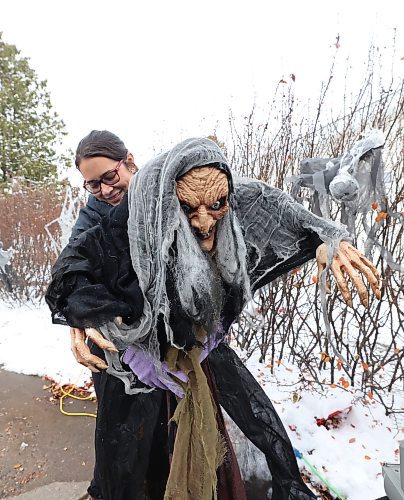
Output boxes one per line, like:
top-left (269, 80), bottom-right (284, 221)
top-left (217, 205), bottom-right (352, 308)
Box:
top-left (45, 197), bottom-right (143, 328)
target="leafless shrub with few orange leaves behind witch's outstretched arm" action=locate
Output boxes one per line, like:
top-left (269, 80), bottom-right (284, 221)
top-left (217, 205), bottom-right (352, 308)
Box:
top-left (227, 40), bottom-right (404, 413)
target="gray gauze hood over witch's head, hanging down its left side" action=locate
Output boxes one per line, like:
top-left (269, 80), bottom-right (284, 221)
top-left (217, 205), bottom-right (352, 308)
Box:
top-left (124, 138), bottom-right (235, 353)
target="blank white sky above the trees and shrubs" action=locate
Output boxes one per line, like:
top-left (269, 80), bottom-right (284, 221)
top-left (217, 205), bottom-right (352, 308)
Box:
top-left (0, 0), bottom-right (404, 174)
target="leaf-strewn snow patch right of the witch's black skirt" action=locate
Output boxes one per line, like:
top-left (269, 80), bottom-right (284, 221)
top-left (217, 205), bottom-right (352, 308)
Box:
top-left (238, 344), bottom-right (404, 500)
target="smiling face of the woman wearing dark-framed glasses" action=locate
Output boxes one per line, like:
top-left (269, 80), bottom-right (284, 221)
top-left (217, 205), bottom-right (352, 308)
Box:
top-left (79, 153), bottom-right (136, 206)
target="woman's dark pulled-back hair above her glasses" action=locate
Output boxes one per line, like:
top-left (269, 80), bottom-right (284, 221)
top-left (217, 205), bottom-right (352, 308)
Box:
top-left (75, 130), bottom-right (128, 168)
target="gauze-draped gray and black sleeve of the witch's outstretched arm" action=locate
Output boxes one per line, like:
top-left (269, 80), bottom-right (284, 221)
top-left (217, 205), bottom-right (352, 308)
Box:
top-left (235, 180), bottom-right (349, 291)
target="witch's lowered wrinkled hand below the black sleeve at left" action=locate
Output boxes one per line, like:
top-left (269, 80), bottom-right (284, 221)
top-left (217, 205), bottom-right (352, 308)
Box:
top-left (70, 328), bottom-right (118, 373)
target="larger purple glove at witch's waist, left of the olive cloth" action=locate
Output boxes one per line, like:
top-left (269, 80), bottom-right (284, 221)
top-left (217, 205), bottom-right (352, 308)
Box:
top-left (122, 347), bottom-right (188, 398)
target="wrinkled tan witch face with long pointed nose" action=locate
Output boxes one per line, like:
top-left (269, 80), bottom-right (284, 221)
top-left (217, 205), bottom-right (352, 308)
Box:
top-left (177, 165), bottom-right (229, 252)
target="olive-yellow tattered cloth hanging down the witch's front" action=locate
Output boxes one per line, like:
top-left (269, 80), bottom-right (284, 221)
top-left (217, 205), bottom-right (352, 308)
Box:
top-left (164, 332), bottom-right (226, 500)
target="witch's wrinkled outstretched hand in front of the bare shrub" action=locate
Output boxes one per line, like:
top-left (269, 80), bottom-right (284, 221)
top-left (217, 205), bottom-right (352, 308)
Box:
top-left (316, 241), bottom-right (381, 307)
